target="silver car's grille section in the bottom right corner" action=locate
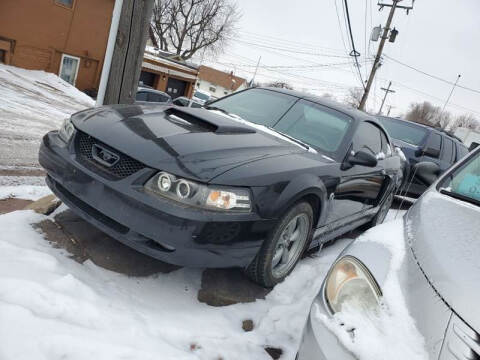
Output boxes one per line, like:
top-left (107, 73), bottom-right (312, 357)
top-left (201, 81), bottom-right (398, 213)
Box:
top-left (440, 314), bottom-right (480, 360)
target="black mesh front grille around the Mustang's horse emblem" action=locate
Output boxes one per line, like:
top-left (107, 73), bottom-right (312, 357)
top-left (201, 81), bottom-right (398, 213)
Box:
top-left (75, 131), bottom-right (145, 180)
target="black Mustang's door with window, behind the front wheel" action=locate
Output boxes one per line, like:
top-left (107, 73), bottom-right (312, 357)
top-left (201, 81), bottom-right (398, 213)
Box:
top-left (327, 121), bottom-right (387, 223)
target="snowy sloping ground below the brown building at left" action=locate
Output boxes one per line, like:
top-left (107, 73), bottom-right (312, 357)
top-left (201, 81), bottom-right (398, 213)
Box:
top-left (0, 64), bottom-right (94, 169)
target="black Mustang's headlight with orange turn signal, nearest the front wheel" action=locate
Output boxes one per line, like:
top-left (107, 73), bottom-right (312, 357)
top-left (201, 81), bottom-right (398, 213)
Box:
top-left (145, 171), bottom-right (251, 212)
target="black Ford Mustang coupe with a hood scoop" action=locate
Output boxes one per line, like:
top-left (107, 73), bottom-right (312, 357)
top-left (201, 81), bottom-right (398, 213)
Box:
top-left (39, 88), bottom-right (403, 286)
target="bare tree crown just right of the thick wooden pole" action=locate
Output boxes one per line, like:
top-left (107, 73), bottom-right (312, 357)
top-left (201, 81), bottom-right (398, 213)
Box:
top-left (152, 0), bottom-right (240, 60)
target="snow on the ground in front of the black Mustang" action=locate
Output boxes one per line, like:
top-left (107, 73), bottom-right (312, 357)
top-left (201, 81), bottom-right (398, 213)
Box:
top-left (0, 211), bottom-right (347, 360)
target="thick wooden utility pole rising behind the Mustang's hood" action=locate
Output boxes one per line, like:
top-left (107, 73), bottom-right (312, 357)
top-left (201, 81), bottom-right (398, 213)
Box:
top-left (102, 0), bottom-right (154, 105)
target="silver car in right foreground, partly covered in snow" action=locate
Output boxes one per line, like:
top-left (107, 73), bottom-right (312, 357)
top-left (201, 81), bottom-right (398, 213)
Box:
top-left (298, 149), bottom-right (480, 360)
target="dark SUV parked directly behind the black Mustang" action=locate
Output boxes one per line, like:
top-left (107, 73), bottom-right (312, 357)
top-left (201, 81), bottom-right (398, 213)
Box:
top-left (377, 116), bottom-right (468, 198)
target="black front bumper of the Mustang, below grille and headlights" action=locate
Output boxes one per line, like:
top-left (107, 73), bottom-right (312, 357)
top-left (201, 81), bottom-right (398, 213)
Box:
top-left (39, 132), bottom-right (275, 267)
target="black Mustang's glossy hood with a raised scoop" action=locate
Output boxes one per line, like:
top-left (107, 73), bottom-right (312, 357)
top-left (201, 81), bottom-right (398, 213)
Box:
top-left (72, 105), bottom-right (307, 182)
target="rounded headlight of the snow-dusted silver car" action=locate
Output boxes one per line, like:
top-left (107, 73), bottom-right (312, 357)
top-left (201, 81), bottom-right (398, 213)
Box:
top-left (325, 256), bottom-right (381, 313)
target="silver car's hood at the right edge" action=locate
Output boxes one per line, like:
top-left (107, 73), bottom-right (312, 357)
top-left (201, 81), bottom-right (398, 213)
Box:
top-left (406, 188), bottom-right (480, 332)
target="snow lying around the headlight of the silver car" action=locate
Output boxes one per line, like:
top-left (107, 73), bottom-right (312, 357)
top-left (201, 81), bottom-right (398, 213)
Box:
top-left (318, 219), bottom-right (428, 360)
